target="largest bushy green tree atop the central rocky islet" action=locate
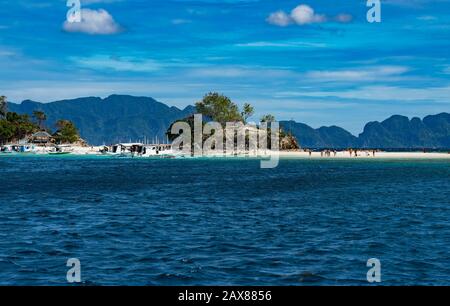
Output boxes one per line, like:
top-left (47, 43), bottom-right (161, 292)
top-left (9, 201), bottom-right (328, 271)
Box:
top-left (195, 92), bottom-right (243, 125)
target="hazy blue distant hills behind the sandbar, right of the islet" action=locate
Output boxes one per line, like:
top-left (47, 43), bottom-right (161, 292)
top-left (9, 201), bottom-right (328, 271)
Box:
top-left (280, 113), bottom-right (450, 149)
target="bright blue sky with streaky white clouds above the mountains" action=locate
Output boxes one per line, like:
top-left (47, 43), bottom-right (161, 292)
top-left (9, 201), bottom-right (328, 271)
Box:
top-left (0, 0), bottom-right (450, 134)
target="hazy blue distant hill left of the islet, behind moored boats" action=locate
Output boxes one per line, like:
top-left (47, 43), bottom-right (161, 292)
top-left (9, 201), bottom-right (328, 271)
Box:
top-left (8, 95), bottom-right (195, 145)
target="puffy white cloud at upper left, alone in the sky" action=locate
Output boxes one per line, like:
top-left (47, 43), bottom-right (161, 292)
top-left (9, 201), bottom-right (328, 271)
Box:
top-left (63, 9), bottom-right (122, 35)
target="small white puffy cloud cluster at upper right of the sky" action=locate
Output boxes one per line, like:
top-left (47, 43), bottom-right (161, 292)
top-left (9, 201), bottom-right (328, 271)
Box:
top-left (267, 4), bottom-right (352, 27)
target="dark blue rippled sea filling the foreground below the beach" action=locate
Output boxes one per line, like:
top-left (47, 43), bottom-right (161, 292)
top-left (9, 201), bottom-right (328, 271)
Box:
top-left (0, 156), bottom-right (450, 285)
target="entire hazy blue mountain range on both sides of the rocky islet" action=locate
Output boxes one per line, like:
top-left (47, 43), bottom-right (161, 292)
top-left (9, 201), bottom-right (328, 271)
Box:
top-left (8, 95), bottom-right (450, 149)
